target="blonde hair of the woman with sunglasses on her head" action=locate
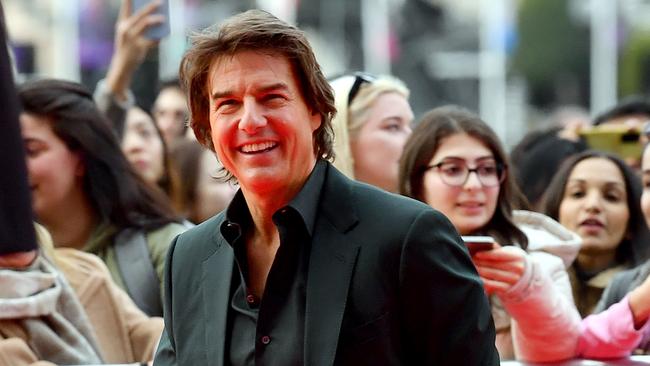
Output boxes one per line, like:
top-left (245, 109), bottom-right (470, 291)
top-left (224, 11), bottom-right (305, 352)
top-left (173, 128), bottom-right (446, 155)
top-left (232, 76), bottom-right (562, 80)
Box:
top-left (330, 75), bottom-right (409, 179)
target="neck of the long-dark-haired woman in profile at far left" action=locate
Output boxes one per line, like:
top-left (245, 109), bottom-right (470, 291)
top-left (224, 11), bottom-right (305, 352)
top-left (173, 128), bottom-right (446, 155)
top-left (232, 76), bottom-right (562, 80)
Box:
top-left (39, 198), bottom-right (97, 249)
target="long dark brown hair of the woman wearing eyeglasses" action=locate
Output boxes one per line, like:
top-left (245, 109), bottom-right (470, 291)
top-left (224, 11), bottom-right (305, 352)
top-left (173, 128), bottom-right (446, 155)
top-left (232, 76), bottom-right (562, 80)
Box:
top-left (399, 106), bottom-right (528, 249)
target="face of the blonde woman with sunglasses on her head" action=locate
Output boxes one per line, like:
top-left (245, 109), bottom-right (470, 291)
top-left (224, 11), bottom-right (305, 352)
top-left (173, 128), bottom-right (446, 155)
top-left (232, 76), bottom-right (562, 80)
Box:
top-left (350, 92), bottom-right (413, 192)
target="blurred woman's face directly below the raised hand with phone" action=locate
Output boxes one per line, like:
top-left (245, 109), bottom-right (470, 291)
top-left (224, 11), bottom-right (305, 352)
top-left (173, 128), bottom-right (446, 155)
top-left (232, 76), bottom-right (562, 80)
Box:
top-left (122, 107), bottom-right (165, 185)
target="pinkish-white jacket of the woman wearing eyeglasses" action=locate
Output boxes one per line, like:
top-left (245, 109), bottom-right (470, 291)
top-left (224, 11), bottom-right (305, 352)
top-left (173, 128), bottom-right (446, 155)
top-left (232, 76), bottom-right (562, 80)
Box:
top-left (497, 211), bottom-right (582, 362)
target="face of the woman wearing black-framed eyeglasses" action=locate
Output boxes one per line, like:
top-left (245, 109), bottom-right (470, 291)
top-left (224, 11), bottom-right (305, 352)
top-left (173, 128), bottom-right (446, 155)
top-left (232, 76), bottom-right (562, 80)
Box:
top-left (422, 133), bottom-right (500, 235)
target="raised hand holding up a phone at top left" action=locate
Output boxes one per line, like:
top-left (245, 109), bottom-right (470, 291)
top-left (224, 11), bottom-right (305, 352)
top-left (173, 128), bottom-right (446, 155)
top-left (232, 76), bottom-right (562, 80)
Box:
top-left (106, 0), bottom-right (165, 100)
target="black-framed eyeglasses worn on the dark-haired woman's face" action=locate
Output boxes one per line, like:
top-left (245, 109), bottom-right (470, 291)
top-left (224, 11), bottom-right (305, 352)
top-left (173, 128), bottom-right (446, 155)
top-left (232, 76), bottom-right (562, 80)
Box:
top-left (425, 161), bottom-right (507, 187)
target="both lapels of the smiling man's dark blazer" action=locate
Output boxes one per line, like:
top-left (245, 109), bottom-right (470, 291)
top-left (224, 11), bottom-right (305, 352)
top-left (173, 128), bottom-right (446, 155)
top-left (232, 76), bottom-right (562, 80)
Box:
top-left (202, 163), bottom-right (359, 366)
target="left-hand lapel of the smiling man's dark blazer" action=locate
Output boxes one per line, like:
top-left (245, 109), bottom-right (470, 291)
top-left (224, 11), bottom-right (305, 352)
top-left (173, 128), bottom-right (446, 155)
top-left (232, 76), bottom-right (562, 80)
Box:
top-left (199, 236), bottom-right (234, 366)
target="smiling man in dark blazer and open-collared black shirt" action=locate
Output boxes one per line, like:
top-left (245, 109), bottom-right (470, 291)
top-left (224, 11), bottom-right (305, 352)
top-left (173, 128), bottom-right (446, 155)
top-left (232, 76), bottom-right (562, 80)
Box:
top-left (155, 10), bottom-right (499, 366)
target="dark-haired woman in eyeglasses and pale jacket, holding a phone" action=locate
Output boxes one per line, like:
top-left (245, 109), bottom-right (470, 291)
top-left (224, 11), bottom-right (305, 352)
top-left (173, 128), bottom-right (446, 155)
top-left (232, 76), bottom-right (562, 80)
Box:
top-left (399, 106), bottom-right (580, 362)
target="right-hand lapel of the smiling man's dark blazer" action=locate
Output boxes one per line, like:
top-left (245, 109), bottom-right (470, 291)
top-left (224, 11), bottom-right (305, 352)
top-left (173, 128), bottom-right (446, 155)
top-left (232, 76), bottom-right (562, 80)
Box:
top-left (305, 166), bottom-right (359, 366)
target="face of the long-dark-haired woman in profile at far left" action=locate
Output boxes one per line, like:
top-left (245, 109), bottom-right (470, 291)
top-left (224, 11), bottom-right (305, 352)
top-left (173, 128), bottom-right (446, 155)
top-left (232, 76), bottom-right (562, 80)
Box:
top-left (20, 113), bottom-right (84, 221)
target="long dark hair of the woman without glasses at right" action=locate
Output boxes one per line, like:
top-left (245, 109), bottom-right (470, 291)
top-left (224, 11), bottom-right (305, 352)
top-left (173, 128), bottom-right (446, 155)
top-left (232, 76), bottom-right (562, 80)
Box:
top-left (542, 150), bottom-right (650, 266)
